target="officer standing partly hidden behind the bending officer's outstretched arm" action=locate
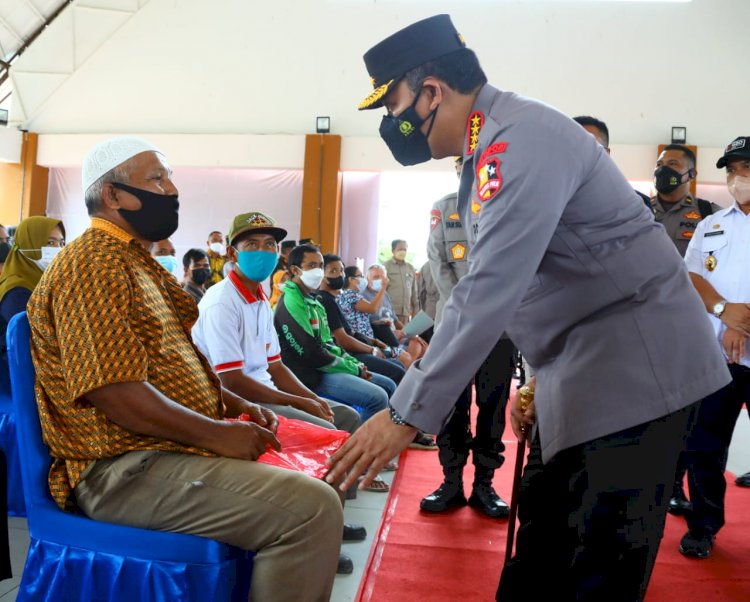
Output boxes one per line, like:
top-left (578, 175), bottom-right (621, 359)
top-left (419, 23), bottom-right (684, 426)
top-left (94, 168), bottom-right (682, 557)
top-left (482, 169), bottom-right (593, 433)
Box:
top-left (419, 189), bottom-right (515, 518)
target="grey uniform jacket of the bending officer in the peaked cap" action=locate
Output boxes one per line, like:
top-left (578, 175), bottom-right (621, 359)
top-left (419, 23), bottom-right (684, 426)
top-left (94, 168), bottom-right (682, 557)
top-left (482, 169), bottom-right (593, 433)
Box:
top-left (391, 85), bottom-right (730, 462)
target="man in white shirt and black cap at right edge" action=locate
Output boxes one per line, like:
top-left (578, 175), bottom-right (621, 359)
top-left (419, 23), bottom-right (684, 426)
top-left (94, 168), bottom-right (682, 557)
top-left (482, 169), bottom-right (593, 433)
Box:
top-left (679, 136), bottom-right (750, 558)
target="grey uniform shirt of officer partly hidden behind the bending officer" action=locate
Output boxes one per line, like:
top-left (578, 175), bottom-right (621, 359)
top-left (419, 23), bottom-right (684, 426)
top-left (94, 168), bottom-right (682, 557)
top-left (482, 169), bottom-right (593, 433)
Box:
top-left (427, 192), bottom-right (469, 325)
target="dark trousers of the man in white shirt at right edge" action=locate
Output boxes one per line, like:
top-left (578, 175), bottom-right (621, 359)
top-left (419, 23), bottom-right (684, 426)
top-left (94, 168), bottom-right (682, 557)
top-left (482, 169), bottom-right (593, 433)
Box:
top-left (687, 364), bottom-right (750, 535)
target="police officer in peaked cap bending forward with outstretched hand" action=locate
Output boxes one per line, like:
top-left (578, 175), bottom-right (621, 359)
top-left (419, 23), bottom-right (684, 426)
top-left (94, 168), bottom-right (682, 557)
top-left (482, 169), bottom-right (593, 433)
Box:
top-left (327, 15), bottom-right (730, 600)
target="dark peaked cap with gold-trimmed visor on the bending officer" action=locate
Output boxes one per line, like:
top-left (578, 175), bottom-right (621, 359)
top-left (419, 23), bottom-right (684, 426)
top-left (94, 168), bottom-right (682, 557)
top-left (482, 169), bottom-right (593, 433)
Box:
top-left (359, 15), bottom-right (466, 111)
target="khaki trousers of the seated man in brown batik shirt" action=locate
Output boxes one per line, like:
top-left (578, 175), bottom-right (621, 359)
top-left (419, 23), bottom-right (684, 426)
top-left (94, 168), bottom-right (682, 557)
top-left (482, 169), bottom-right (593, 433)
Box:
top-left (75, 451), bottom-right (343, 602)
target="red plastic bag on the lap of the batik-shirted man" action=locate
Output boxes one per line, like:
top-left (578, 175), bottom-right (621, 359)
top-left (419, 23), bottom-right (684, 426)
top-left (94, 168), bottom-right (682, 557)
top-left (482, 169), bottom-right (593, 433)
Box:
top-left (228, 414), bottom-right (349, 479)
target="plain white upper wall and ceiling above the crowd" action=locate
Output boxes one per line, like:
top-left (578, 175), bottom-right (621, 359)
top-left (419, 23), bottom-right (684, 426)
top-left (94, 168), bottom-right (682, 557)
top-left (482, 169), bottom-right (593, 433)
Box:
top-left (5, 0), bottom-right (750, 147)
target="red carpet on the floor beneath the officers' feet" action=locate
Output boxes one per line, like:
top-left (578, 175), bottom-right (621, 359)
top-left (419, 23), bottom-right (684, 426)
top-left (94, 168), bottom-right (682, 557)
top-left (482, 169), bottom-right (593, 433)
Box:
top-left (357, 434), bottom-right (750, 602)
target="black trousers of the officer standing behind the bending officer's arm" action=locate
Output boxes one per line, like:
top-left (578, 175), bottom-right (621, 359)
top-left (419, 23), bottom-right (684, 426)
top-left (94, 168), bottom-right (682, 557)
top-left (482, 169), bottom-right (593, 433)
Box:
top-left (437, 339), bottom-right (515, 476)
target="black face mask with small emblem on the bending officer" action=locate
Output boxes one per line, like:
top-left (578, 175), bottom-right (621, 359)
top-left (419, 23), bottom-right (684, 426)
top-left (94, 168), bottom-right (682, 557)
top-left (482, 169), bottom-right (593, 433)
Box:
top-left (380, 90), bottom-right (439, 165)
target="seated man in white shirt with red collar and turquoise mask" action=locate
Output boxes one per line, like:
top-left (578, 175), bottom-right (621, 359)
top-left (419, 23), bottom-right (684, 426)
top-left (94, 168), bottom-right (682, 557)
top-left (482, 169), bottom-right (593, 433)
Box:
top-left (192, 211), bottom-right (360, 433)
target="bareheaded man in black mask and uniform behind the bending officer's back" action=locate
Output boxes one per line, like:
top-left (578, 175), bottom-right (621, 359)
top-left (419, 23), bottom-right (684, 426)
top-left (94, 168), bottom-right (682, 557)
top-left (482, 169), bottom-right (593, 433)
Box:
top-left (651, 144), bottom-right (721, 257)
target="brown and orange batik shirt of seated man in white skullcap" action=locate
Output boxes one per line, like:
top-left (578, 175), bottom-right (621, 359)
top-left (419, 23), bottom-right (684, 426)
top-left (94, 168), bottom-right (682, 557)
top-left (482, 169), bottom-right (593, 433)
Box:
top-left (28, 218), bottom-right (224, 508)
